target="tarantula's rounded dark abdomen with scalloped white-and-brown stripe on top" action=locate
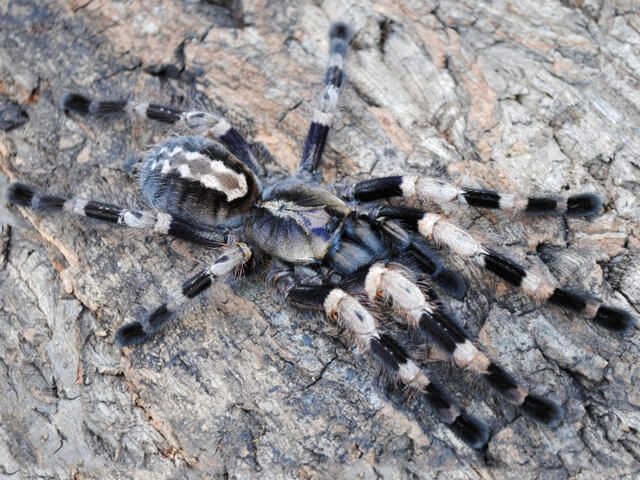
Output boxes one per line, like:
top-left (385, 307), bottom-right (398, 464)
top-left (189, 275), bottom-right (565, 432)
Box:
top-left (139, 137), bottom-right (259, 225)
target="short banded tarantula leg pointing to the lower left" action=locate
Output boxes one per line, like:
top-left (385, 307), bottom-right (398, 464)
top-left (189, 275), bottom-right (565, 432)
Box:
top-left (115, 243), bottom-right (251, 348)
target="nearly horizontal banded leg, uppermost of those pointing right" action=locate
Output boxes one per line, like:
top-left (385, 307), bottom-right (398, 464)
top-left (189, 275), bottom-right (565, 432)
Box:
top-left (345, 175), bottom-right (602, 217)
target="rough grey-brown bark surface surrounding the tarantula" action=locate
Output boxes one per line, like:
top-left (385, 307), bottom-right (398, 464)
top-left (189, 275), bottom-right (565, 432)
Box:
top-left (0, 0), bottom-right (640, 479)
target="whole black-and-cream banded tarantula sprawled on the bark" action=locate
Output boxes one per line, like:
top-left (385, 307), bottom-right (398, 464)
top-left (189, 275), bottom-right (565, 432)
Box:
top-left (9, 23), bottom-right (634, 448)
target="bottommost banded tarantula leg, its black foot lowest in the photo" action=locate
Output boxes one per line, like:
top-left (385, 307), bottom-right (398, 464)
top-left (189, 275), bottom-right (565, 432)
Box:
top-left (287, 285), bottom-right (489, 448)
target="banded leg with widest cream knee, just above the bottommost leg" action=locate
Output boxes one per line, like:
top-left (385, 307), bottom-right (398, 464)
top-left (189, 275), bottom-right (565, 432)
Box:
top-left (364, 263), bottom-right (563, 426)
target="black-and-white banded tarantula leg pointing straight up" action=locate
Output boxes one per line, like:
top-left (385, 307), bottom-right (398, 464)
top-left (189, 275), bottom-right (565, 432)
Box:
top-left (300, 23), bottom-right (351, 173)
